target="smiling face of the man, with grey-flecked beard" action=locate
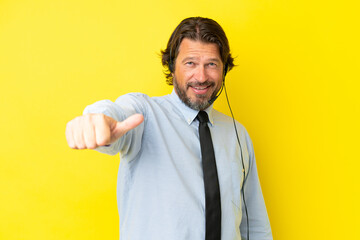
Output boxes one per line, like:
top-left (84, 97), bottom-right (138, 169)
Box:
top-left (173, 38), bottom-right (223, 110)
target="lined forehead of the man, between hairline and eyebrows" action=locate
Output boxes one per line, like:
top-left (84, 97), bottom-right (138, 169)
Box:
top-left (178, 38), bottom-right (221, 60)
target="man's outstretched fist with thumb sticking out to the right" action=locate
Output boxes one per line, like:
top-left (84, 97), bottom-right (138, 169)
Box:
top-left (65, 114), bottom-right (144, 149)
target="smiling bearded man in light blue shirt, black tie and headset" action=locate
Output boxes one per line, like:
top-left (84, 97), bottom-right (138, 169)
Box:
top-left (66, 17), bottom-right (272, 240)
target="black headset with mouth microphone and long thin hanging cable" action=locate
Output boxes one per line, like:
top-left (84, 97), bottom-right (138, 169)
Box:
top-left (168, 47), bottom-right (250, 240)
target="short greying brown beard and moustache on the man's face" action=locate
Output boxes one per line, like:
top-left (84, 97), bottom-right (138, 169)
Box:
top-left (173, 76), bottom-right (220, 111)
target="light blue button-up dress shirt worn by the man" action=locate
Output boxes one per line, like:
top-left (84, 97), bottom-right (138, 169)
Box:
top-left (84, 91), bottom-right (272, 240)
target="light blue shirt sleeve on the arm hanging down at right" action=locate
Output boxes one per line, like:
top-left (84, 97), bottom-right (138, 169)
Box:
top-left (240, 130), bottom-right (273, 240)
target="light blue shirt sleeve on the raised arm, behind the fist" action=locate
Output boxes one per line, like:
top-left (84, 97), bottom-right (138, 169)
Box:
top-left (83, 93), bottom-right (146, 159)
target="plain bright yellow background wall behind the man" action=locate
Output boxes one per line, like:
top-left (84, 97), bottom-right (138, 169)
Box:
top-left (0, 0), bottom-right (360, 240)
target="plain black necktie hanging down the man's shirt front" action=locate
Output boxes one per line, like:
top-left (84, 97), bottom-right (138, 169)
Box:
top-left (196, 111), bottom-right (221, 240)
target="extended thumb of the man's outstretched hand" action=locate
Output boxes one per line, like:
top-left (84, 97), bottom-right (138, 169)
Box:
top-left (110, 114), bottom-right (144, 142)
